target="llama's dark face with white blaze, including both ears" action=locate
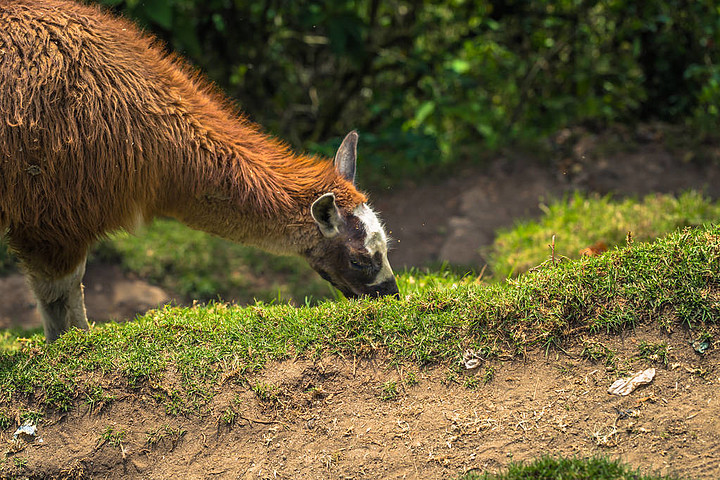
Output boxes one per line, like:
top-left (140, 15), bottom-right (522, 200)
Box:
top-left (306, 132), bottom-right (398, 298)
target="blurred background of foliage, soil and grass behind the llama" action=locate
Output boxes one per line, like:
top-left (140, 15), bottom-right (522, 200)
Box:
top-left (0, 0), bottom-right (720, 326)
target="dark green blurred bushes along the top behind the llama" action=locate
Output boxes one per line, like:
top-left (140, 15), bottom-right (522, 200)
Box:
top-left (96, 0), bottom-right (720, 183)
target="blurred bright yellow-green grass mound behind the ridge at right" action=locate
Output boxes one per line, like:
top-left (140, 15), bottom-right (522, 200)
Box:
top-left (489, 192), bottom-right (720, 278)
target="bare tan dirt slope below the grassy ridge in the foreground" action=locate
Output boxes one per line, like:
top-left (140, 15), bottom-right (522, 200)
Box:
top-left (0, 327), bottom-right (720, 480)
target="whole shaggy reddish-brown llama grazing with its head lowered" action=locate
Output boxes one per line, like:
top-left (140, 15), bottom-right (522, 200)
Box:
top-left (0, 0), bottom-right (398, 342)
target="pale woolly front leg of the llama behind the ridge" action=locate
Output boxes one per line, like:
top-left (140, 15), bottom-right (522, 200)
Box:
top-left (28, 259), bottom-right (88, 343)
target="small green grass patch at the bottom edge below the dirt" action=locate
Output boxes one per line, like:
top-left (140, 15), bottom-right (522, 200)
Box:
top-left (460, 456), bottom-right (677, 480)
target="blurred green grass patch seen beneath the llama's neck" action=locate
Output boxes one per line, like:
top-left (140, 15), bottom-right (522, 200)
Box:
top-left (95, 219), bottom-right (332, 303)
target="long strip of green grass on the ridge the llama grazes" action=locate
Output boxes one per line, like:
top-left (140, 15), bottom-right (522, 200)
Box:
top-left (0, 226), bottom-right (720, 416)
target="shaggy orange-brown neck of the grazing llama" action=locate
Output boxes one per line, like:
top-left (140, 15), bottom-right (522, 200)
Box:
top-left (139, 59), bottom-right (366, 253)
